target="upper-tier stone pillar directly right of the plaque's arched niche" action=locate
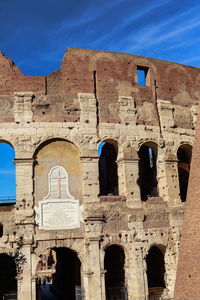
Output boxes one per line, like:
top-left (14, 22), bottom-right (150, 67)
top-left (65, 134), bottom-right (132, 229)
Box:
top-left (81, 156), bottom-right (99, 203)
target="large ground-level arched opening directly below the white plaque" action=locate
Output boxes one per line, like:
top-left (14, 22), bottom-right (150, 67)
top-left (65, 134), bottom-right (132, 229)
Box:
top-left (36, 247), bottom-right (84, 300)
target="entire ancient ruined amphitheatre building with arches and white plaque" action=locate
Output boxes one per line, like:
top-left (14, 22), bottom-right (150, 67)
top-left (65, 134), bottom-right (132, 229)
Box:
top-left (0, 49), bottom-right (200, 300)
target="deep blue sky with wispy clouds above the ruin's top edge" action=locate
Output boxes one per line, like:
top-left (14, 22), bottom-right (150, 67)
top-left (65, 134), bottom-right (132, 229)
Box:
top-left (0, 0), bottom-right (200, 75)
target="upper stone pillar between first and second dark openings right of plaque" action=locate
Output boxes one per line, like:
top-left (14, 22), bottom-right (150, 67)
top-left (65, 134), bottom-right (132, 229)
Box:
top-left (117, 158), bottom-right (141, 208)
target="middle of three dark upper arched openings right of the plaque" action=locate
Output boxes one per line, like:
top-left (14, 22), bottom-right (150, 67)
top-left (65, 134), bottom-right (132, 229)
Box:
top-left (138, 142), bottom-right (158, 201)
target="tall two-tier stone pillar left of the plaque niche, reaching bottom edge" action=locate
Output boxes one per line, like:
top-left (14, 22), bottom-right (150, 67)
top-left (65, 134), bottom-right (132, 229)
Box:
top-left (14, 158), bottom-right (36, 300)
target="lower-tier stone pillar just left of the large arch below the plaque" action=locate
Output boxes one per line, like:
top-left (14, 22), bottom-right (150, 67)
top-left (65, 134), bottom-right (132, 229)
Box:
top-left (17, 244), bottom-right (32, 300)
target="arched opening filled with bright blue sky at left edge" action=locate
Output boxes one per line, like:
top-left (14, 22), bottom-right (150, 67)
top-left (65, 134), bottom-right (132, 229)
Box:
top-left (0, 142), bottom-right (16, 205)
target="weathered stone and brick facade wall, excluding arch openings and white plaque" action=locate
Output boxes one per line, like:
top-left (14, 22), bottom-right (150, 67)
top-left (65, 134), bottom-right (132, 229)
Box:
top-left (0, 49), bottom-right (200, 300)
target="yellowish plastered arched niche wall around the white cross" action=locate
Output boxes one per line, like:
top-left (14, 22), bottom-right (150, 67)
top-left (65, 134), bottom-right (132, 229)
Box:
top-left (34, 139), bottom-right (83, 205)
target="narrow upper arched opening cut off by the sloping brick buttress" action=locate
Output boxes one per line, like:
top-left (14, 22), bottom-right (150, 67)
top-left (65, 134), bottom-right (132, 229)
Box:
top-left (177, 144), bottom-right (192, 202)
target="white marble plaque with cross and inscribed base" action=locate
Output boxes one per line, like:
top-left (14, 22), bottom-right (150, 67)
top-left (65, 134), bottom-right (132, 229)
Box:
top-left (39, 166), bottom-right (80, 230)
